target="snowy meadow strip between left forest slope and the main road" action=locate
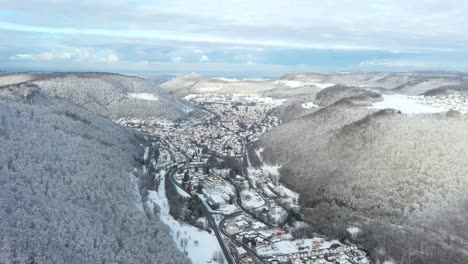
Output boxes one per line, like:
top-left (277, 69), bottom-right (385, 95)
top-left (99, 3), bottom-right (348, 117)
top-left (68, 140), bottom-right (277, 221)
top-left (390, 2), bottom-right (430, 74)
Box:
top-left (148, 171), bottom-right (221, 264)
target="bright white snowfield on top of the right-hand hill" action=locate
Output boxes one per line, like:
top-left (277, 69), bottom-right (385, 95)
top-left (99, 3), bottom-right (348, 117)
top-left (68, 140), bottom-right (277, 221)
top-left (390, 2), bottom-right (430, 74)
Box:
top-left (370, 94), bottom-right (447, 114)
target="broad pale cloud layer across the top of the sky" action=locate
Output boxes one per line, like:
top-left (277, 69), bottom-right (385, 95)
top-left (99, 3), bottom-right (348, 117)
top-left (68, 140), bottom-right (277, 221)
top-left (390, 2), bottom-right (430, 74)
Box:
top-left (0, 0), bottom-right (468, 52)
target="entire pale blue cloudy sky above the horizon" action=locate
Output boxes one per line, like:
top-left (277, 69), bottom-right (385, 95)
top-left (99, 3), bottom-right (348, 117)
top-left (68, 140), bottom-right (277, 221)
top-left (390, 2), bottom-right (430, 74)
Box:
top-left (0, 0), bottom-right (468, 76)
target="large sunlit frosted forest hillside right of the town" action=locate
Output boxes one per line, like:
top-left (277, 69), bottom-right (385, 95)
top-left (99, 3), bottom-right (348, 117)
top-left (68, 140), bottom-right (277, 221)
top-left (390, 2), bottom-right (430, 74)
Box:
top-left (254, 92), bottom-right (468, 263)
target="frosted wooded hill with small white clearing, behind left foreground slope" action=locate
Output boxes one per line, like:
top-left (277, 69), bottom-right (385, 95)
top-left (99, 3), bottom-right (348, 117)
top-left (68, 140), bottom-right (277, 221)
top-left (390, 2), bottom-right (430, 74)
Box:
top-left (0, 73), bottom-right (197, 120)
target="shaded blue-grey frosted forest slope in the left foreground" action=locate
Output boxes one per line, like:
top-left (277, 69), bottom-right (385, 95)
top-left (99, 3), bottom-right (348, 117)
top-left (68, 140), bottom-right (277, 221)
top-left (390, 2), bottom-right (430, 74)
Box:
top-left (0, 84), bottom-right (189, 264)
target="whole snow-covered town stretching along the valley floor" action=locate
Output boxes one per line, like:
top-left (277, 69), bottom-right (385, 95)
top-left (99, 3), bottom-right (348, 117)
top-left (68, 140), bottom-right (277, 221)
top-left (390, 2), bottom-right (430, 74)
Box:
top-left (118, 94), bottom-right (370, 264)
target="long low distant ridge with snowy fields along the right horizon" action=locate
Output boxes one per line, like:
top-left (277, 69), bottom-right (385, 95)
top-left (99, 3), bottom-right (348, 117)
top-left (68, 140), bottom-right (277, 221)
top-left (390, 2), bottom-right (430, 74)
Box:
top-left (161, 72), bottom-right (468, 98)
